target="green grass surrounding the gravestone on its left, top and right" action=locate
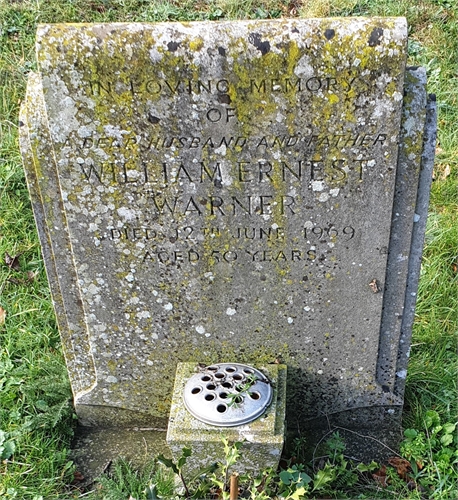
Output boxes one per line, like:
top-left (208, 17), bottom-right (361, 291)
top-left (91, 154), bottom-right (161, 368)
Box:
top-left (0, 0), bottom-right (458, 500)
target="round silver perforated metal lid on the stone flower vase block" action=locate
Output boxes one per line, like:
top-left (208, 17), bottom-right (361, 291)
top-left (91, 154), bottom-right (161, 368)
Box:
top-left (183, 363), bottom-right (272, 427)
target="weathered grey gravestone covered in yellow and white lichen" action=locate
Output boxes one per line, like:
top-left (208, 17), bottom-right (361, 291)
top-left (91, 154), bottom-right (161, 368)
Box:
top-left (21, 18), bottom-right (434, 468)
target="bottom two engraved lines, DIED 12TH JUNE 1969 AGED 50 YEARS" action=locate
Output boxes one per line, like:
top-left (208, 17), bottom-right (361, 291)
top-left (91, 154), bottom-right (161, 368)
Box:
top-left (105, 221), bottom-right (356, 266)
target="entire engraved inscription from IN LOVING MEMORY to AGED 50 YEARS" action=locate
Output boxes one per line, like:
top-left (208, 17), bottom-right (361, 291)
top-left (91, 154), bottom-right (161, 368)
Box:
top-left (69, 42), bottom-right (393, 276)
